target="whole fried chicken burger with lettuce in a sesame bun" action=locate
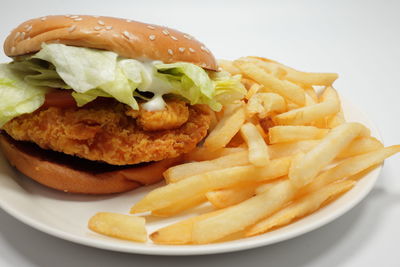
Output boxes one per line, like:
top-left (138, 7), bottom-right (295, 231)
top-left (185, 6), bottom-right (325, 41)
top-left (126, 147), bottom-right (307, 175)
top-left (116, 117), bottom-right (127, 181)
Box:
top-left (0, 15), bottom-right (245, 194)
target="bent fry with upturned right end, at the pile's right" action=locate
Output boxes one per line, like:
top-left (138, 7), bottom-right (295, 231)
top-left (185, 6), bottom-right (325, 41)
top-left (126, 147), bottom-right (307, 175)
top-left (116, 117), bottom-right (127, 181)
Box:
top-left (274, 87), bottom-right (340, 125)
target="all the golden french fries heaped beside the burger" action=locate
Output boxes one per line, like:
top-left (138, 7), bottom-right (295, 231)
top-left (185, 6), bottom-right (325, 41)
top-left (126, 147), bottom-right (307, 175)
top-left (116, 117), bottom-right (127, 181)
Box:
top-left (89, 57), bottom-right (400, 245)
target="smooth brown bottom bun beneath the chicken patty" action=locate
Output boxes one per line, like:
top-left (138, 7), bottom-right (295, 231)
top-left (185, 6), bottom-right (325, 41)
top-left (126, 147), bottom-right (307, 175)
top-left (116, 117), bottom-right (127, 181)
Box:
top-left (0, 133), bottom-right (182, 194)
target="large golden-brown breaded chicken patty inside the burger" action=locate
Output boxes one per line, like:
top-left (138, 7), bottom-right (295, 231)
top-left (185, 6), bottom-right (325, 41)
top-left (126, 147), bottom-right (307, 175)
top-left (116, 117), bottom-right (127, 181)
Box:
top-left (3, 102), bottom-right (210, 165)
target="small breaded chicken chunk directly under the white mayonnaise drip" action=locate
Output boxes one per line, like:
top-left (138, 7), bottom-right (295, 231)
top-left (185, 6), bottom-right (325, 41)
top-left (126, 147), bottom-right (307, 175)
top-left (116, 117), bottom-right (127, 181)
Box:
top-left (125, 100), bottom-right (189, 131)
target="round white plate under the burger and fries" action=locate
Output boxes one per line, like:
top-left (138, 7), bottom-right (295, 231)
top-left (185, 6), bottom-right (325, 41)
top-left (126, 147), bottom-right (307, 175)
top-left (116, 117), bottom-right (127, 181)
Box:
top-left (0, 98), bottom-right (381, 255)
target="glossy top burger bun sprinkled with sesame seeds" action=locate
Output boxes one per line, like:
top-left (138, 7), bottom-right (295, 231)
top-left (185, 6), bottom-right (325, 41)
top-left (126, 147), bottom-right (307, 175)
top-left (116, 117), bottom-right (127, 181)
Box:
top-left (4, 15), bottom-right (218, 71)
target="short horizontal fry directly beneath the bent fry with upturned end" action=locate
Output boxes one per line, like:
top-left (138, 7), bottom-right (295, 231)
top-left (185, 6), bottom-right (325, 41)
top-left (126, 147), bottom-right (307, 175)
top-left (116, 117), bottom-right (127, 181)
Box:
top-left (268, 125), bottom-right (329, 144)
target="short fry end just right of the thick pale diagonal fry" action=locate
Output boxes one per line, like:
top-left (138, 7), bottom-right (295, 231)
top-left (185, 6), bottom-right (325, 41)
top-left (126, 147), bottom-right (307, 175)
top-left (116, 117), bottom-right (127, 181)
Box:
top-left (336, 137), bottom-right (383, 159)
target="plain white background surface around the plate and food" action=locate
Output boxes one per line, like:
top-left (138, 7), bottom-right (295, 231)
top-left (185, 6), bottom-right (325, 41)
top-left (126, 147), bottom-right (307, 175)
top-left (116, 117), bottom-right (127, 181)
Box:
top-left (0, 0), bottom-right (400, 267)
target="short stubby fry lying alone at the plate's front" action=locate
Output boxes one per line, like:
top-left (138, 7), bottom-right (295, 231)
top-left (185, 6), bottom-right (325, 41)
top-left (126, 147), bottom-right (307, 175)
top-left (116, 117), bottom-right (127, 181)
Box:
top-left (88, 212), bottom-right (147, 242)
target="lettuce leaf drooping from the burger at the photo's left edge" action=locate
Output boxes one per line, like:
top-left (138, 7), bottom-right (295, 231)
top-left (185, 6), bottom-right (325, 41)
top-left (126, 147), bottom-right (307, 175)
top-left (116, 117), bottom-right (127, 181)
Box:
top-left (0, 64), bottom-right (47, 127)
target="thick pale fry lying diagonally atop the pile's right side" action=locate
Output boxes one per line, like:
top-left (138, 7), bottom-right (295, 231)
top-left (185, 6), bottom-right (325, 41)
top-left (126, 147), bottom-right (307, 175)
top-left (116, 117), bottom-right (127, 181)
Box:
top-left (289, 123), bottom-right (369, 187)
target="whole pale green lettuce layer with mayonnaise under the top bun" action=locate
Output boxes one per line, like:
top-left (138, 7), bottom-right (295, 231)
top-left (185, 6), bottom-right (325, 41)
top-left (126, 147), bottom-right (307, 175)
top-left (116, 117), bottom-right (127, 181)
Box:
top-left (0, 44), bottom-right (246, 127)
